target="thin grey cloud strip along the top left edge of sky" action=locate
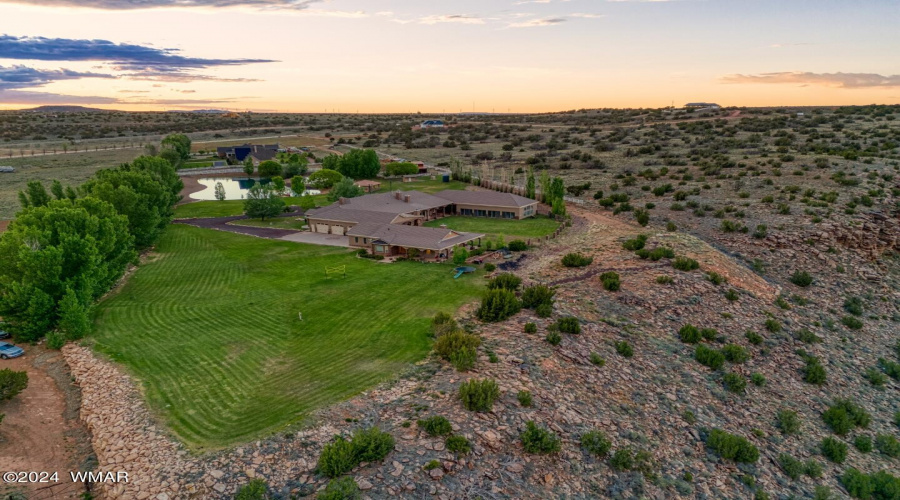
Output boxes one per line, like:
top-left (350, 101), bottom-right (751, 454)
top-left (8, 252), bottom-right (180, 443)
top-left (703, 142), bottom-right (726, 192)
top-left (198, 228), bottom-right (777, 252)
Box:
top-left (0, 0), bottom-right (327, 10)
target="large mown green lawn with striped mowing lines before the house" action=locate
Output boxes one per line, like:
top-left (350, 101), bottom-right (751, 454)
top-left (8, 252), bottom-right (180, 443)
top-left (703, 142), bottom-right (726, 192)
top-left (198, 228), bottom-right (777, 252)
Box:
top-left (93, 225), bottom-right (484, 451)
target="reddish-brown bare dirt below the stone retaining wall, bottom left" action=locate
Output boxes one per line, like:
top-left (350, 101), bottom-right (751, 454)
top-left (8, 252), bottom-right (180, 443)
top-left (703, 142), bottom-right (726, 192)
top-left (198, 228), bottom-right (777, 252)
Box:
top-left (0, 346), bottom-right (93, 499)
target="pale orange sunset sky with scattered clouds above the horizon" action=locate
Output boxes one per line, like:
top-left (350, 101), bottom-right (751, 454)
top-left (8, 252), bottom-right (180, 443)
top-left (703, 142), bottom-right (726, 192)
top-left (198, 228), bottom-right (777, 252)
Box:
top-left (0, 0), bottom-right (900, 113)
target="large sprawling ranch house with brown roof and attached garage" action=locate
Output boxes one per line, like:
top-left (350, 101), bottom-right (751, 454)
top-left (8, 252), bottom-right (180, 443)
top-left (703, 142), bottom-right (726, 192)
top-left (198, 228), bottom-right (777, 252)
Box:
top-left (306, 190), bottom-right (538, 260)
